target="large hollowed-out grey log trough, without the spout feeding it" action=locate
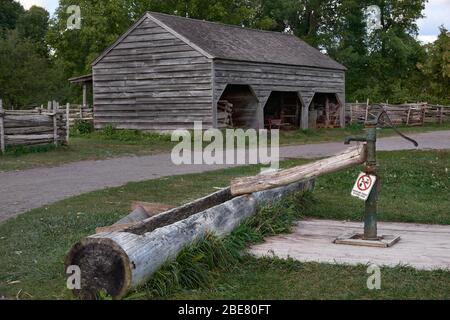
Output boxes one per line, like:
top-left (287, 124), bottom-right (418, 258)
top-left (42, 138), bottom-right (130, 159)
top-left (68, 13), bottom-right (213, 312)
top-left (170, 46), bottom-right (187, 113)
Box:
top-left (66, 180), bottom-right (314, 299)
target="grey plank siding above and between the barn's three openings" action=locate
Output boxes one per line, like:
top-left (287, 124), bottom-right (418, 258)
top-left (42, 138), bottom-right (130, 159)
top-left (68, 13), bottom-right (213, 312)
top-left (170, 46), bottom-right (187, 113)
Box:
top-left (214, 60), bottom-right (345, 127)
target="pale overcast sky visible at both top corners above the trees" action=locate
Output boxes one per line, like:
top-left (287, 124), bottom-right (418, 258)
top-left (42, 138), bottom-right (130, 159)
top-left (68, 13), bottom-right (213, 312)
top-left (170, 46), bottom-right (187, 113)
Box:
top-left (19, 0), bottom-right (450, 42)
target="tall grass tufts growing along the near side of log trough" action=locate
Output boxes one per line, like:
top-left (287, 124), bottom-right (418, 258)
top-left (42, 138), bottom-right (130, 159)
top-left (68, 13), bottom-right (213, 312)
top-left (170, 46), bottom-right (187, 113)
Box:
top-left (126, 192), bottom-right (313, 300)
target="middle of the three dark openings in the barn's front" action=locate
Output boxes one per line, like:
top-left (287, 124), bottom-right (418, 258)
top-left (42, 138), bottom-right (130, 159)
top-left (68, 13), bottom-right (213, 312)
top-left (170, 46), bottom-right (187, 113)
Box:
top-left (264, 91), bottom-right (302, 130)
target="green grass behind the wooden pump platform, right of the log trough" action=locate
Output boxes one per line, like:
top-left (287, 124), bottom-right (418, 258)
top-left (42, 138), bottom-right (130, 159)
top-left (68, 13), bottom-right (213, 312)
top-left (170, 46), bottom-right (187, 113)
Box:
top-left (306, 151), bottom-right (450, 224)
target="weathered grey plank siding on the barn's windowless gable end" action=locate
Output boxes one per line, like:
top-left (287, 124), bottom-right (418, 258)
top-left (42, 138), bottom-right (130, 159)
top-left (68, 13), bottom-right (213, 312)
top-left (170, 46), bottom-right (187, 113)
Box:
top-left (93, 19), bottom-right (213, 131)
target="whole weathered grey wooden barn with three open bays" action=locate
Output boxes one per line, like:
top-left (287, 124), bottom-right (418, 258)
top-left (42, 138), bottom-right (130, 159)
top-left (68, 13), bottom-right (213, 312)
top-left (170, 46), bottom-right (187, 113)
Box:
top-left (92, 12), bottom-right (345, 131)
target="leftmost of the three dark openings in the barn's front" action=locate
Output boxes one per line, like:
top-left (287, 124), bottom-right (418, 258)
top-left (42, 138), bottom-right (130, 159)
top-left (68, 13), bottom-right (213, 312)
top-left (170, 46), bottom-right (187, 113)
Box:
top-left (217, 84), bottom-right (258, 129)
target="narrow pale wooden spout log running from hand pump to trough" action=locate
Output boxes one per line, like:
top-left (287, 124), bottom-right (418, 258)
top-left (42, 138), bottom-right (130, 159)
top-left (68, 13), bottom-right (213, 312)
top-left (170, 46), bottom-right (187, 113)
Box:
top-left (231, 144), bottom-right (367, 196)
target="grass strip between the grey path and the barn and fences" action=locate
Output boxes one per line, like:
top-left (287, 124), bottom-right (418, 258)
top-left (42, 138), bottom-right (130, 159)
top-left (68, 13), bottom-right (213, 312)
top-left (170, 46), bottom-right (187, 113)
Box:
top-left (0, 122), bottom-right (450, 171)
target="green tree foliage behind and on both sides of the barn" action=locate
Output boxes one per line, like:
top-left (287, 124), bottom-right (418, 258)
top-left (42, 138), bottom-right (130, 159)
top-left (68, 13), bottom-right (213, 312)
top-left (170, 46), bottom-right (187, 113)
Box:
top-left (0, 0), bottom-right (450, 108)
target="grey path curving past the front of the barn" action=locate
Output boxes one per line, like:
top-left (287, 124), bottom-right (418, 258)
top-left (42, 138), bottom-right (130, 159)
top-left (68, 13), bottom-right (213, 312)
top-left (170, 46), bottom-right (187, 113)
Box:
top-left (0, 131), bottom-right (450, 223)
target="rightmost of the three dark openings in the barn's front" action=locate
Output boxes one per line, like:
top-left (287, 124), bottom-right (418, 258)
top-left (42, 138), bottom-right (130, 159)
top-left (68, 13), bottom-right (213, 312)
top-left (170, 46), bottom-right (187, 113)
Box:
top-left (309, 93), bottom-right (342, 128)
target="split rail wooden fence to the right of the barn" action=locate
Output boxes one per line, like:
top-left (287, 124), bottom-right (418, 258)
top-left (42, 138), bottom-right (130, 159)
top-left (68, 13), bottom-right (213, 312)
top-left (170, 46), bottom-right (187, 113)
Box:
top-left (346, 103), bottom-right (450, 127)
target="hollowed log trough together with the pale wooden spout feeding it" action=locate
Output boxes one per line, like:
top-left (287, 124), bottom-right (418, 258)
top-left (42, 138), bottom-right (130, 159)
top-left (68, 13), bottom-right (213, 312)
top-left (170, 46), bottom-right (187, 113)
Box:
top-left (65, 145), bottom-right (367, 299)
